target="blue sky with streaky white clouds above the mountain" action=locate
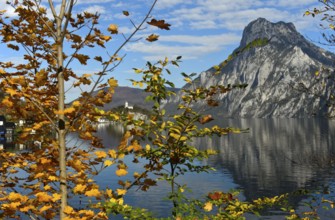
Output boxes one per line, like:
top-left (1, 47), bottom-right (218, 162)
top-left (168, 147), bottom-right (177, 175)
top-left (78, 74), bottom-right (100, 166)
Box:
top-left (0, 0), bottom-right (328, 99)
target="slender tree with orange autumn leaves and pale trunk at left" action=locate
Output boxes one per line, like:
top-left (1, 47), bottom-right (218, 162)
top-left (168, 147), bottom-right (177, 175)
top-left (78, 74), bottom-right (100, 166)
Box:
top-left (0, 0), bottom-right (170, 219)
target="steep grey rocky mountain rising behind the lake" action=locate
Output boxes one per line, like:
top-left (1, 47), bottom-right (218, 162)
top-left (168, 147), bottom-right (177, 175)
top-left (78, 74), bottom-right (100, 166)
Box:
top-left (166, 18), bottom-right (335, 117)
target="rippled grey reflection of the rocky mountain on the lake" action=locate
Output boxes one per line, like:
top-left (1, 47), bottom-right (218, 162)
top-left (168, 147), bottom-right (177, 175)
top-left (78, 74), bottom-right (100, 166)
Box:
top-left (195, 119), bottom-right (335, 200)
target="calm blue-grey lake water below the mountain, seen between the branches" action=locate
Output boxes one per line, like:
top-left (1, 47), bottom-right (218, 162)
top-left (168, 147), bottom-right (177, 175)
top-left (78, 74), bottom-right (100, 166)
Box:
top-left (84, 119), bottom-right (335, 219)
